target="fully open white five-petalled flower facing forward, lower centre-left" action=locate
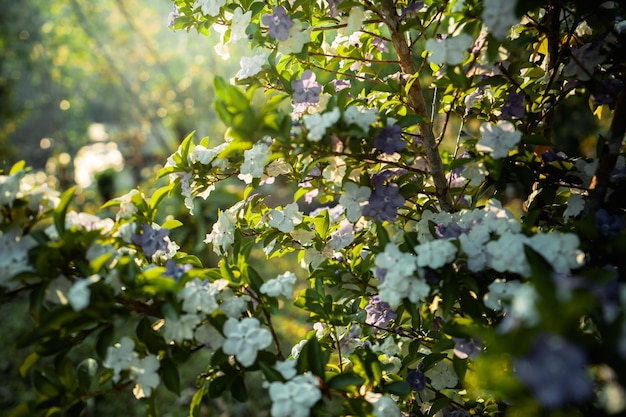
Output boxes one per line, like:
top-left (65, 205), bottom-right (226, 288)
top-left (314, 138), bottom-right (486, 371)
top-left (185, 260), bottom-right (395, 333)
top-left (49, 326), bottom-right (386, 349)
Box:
top-left (222, 317), bottom-right (272, 366)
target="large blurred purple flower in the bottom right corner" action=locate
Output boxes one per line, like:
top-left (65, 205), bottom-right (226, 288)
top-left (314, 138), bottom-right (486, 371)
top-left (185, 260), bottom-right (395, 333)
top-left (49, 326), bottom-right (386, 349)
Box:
top-left (514, 334), bottom-right (593, 409)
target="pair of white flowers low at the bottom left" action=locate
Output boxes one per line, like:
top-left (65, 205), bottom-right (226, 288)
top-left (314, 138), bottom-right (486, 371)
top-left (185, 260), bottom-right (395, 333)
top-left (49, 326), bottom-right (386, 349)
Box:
top-left (102, 336), bottom-right (161, 398)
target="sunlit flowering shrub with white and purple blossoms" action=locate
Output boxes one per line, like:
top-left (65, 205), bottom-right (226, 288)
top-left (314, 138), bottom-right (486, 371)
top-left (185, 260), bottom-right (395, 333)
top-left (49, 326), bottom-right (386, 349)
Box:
top-left (0, 0), bottom-right (626, 417)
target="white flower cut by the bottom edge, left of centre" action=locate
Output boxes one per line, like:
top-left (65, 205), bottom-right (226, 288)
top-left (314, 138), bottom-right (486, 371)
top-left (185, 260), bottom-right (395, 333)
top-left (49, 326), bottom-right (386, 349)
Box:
top-left (269, 373), bottom-right (322, 417)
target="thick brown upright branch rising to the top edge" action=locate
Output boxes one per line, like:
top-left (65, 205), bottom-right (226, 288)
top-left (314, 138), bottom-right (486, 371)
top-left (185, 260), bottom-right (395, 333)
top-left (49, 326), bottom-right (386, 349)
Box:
top-left (381, 0), bottom-right (453, 212)
